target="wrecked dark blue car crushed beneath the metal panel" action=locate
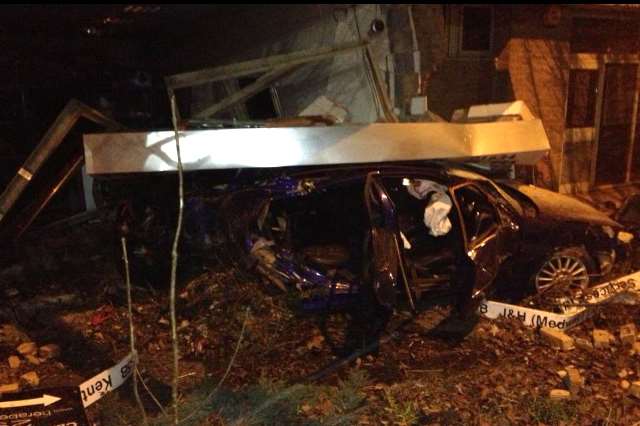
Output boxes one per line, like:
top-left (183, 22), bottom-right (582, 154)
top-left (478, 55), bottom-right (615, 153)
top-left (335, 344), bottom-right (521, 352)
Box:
top-left (221, 162), bottom-right (626, 312)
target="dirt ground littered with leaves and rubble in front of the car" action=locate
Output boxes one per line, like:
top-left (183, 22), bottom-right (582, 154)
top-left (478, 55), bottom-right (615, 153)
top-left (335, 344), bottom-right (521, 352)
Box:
top-left (0, 223), bottom-right (640, 425)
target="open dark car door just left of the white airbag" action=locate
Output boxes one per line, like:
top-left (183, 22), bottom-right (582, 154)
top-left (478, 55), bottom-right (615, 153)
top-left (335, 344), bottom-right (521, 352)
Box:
top-left (364, 172), bottom-right (415, 311)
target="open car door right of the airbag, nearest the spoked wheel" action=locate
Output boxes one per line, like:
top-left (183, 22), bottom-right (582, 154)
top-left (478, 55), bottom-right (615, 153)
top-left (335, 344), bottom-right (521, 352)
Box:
top-left (450, 183), bottom-right (506, 306)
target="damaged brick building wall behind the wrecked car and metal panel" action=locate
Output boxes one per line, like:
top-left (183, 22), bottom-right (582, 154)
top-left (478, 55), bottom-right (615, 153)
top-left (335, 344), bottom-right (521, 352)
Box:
top-left (166, 4), bottom-right (640, 192)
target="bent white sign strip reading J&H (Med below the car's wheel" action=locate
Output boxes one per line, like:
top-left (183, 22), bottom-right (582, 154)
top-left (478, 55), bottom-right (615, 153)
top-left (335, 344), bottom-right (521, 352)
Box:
top-left (478, 271), bottom-right (640, 330)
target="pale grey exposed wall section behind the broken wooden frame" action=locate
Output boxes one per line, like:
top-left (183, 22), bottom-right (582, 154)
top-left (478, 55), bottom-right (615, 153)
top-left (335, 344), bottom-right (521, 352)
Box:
top-left (254, 4), bottom-right (390, 123)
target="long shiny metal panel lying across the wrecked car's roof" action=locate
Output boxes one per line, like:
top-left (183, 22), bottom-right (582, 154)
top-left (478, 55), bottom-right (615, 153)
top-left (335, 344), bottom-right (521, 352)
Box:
top-left (84, 120), bottom-right (549, 174)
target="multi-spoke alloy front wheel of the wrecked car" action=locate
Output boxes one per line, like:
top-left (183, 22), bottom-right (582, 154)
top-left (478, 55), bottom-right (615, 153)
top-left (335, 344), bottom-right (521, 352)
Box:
top-left (533, 247), bottom-right (594, 296)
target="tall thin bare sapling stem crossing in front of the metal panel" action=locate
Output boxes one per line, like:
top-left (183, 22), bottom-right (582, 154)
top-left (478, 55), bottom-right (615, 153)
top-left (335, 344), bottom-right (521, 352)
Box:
top-left (169, 90), bottom-right (184, 425)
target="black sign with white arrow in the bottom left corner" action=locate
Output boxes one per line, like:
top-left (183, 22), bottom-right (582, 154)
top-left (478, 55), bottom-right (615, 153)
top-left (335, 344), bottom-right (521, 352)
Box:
top-left (0, 386), bottom-right (89, 426)
